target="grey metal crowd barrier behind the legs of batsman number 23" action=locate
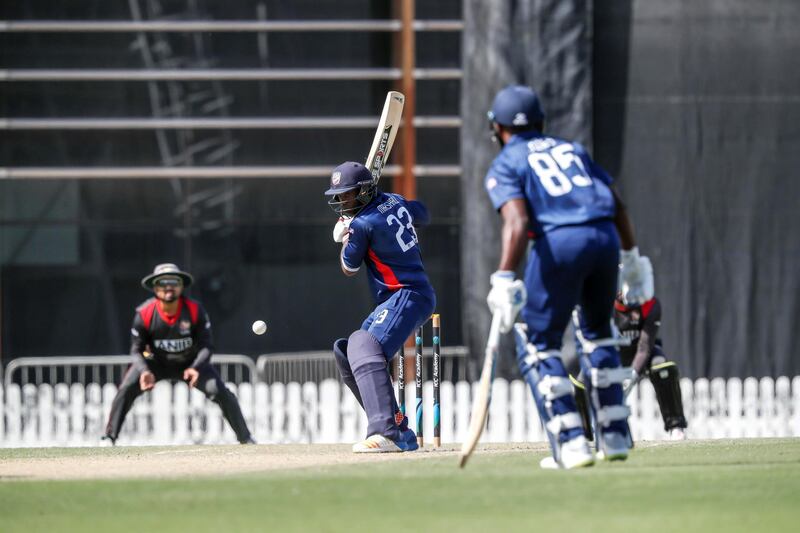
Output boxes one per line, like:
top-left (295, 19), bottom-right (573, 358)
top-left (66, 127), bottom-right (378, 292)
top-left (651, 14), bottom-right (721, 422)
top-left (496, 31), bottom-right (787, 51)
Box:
top-left (256, 346), bottom-right (468, 385)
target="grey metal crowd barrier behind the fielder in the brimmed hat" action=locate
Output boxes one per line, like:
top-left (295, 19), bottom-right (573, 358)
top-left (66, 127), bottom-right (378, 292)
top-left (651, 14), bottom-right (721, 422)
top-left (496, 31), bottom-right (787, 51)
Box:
top-left (3, 354), bottom-right (257, 388)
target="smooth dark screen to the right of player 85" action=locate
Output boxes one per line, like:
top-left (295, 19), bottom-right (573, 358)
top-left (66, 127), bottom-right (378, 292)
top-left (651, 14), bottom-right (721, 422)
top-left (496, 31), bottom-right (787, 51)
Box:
top-left (594, 0), bottom-right (800, 377)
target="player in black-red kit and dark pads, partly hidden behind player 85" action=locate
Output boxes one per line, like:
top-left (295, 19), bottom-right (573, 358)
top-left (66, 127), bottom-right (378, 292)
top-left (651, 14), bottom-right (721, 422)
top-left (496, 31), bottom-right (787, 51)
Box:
top-left (614, 294), bottom-right (687, 440)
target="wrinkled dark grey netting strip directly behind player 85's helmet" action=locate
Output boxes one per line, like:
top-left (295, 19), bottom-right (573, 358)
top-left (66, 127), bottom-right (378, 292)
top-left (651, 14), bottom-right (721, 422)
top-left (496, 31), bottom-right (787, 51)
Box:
top-left (461, 0), bottom-right (592, 374)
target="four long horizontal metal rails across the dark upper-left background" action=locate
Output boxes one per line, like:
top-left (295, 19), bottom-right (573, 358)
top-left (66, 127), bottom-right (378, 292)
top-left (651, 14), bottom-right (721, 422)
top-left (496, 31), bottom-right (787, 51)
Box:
top-left (0, 15), bottom-right (464, 179)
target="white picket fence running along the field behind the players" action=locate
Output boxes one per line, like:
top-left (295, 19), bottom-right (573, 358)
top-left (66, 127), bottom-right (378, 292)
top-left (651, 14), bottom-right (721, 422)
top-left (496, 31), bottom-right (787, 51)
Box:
top-left (0, 376), bottom-right (800, 447)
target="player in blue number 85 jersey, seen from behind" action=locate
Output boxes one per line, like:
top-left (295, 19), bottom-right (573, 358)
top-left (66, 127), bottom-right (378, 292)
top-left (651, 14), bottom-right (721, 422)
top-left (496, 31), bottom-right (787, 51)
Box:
top-left (484, 86), bottom-right (652, 468)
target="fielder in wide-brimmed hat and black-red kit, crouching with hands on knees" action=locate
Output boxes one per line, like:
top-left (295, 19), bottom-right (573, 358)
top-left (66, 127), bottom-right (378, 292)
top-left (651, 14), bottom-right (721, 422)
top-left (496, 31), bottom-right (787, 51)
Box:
top-left (103, 263), bottom-right (254, 444)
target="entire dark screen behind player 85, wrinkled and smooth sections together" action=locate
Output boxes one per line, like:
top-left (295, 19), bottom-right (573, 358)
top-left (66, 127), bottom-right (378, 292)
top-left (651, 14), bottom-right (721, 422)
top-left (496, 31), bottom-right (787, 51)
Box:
top-left (462, 0), bottom-right (800, 377)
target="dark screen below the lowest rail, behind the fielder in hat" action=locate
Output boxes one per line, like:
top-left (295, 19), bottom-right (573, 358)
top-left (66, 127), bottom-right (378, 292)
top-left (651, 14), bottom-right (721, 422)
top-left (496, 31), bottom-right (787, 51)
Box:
top-left (0, 177), bottom-right (460, 359)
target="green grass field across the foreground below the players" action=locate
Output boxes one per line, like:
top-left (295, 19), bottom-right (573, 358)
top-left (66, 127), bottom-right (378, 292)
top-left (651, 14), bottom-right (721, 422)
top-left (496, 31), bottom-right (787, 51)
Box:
top-left (0, 439), bottom-right (800, 533)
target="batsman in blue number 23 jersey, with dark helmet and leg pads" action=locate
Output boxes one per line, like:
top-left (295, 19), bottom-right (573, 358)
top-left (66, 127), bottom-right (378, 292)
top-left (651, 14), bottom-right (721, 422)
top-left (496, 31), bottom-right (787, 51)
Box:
top-left (325, 162), bottom-right (436, 453)
